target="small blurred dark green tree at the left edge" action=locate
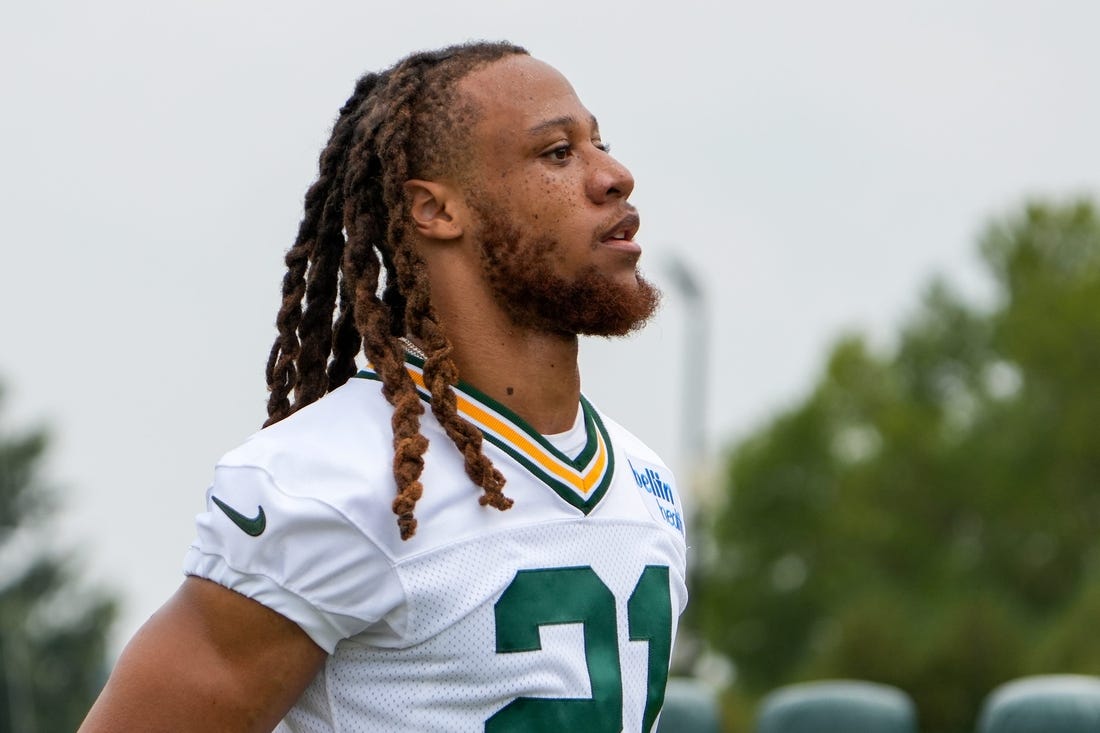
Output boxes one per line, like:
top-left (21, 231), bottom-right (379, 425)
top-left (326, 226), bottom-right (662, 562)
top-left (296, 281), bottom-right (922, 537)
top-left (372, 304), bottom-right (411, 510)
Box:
top-left (0, 392), bottom-right (116, 733)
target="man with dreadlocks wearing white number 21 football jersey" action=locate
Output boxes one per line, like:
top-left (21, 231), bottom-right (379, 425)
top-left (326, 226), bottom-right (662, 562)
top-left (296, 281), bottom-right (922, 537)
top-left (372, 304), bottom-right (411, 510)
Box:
top-left (81, 43), bottom-right (686, 733)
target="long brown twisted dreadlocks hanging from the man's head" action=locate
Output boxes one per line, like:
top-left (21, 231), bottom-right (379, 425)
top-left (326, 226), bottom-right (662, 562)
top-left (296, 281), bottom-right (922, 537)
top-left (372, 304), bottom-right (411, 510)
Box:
top-left (264, 42), bottom-right (527, 539)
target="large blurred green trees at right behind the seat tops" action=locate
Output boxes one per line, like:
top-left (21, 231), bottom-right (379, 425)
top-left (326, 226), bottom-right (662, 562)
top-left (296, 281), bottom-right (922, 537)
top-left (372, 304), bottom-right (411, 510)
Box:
top-left (693, 201), bottom-right (1100, 733)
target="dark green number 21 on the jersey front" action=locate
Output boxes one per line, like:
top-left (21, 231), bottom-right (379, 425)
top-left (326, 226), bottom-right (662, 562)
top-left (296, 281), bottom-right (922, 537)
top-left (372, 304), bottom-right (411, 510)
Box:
top-left (485, 565), bottom-right (672, 733)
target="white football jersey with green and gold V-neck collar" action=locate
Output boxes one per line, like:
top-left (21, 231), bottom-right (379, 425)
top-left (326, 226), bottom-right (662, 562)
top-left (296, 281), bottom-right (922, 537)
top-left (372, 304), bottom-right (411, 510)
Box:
top-left (185, 357), bottom-right (688, 733)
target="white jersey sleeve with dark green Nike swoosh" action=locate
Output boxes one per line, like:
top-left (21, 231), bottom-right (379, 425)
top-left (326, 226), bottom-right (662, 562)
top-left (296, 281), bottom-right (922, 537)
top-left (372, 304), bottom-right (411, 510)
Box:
top-left (184, 466), bottom-right (404, 654)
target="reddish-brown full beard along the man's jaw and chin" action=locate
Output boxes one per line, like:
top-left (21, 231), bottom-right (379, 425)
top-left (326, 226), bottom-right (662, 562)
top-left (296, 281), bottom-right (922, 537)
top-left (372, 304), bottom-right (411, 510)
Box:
top-left (471, 201), bottom-right (661, 336)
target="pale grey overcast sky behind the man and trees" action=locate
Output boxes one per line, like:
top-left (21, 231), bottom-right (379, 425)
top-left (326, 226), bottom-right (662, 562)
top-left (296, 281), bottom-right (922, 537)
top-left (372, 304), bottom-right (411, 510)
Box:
top-left (0, 0), bottom-right (1100, 647)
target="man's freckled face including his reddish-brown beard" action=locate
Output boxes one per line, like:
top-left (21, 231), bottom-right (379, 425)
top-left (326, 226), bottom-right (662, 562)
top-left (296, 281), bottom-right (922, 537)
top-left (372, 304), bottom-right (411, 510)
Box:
top-left (453, 56), bottom-right (658, 336)
